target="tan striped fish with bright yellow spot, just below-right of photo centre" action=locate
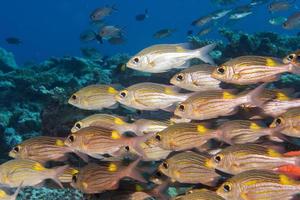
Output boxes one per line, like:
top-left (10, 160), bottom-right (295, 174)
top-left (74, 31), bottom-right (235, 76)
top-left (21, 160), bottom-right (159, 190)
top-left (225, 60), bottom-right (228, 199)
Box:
top-left (153, 123), bottom-right (216, 151)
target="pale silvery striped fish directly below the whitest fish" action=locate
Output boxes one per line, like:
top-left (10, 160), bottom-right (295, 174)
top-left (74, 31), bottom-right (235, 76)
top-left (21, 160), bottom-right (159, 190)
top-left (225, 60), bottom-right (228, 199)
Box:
top-left (115, 82), bottom-right (191, 110)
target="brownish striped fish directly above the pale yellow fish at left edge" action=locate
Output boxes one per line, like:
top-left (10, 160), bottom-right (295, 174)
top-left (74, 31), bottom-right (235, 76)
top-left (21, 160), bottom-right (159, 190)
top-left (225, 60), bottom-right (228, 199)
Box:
top-left (9, 136), bottom-right (86, 164)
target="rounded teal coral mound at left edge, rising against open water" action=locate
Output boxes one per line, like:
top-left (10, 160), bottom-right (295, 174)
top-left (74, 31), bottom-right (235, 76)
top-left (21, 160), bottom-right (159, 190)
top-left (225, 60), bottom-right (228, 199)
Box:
top-left (0, 48), bottom-right (18, 72)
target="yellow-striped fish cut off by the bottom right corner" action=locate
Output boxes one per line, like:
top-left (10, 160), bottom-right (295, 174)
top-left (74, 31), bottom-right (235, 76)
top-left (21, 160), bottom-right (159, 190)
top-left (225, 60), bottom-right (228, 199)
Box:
top-left (217, 170), bottom-right (300, 200)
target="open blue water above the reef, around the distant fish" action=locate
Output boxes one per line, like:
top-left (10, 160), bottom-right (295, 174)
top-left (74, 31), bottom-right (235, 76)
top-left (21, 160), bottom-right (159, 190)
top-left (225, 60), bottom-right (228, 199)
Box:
top-left (0, 0), bottom-right (300, 65)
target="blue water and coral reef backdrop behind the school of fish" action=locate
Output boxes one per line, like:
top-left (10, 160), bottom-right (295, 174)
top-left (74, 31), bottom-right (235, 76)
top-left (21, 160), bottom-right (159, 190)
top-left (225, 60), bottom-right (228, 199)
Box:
top-left (0, 0), bottom-right (300, 199)
